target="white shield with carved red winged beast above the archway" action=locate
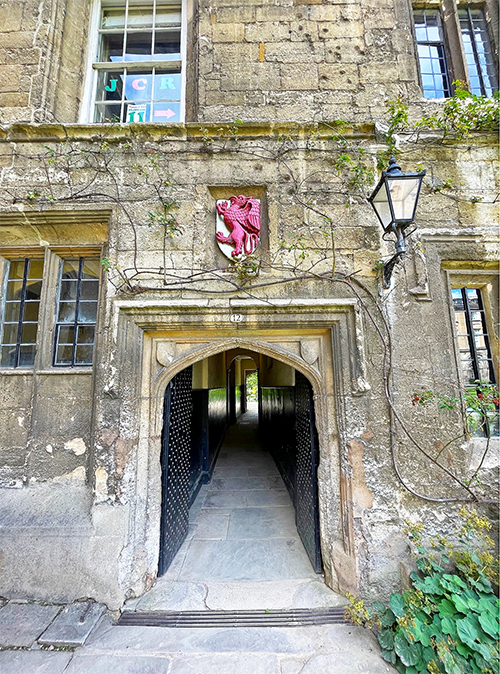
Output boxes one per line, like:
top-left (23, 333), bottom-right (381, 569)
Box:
top-left (216, 194), bottom-right (260, 259)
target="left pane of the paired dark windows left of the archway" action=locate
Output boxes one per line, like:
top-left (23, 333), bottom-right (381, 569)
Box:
top-left (0, 258), bottom-right (43, 367)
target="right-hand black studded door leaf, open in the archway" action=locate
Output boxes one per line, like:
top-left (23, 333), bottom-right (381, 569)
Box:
top-left (295, 371), bottom-right (322, 573)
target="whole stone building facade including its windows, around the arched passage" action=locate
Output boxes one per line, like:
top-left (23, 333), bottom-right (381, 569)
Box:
top-left (0, 0), bottom-right (499, 608)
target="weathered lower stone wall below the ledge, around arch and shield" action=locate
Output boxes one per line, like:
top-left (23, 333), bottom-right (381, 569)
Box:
top-left (0, 125), bottom-right (498, 604)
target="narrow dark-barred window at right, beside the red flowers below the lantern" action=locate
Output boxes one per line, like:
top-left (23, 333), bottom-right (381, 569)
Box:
top-left (451, 287), bottom-right (498, 437)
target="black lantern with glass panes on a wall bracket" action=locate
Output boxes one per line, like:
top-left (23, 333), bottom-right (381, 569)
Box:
top-left (368, 157), bottom-right (426, 288)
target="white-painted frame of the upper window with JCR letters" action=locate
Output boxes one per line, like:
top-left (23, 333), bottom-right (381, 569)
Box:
top-left (79, 0), bottom-right (188, 124)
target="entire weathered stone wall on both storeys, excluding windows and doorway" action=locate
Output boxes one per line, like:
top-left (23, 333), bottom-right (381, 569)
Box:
top-left (0, 0), bottom-right (498, 607)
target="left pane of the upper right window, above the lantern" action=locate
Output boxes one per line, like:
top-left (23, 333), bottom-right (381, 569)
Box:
top-left (413, 9), bottom-right (451, 98)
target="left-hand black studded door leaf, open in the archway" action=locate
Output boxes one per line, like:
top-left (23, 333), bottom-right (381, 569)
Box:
top-left (158, 367), bottom-right (193, 575)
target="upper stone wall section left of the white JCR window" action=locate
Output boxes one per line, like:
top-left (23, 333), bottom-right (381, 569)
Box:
top-left (0, 0), bottom-right (91, 124)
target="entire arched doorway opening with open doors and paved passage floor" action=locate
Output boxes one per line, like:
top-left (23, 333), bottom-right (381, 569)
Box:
top-left (159, 349), bottom-right (322, 581)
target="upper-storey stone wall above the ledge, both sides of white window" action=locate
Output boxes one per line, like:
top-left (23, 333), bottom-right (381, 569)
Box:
top-left (0, 0), bottom-right (498, 123)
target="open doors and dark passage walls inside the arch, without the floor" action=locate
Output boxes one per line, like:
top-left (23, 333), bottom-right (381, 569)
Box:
top-left (158, 349), bottom-right (322, 575)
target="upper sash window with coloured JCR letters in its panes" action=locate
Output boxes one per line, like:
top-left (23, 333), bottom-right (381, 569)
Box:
top-left (94, 0), bottom-right (182, 123)
